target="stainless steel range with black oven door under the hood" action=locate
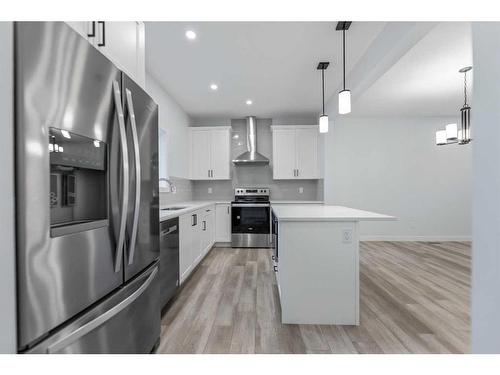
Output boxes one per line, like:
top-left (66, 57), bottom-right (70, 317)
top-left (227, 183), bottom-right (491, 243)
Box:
top-left (231, 188), bottom-right (272, 247)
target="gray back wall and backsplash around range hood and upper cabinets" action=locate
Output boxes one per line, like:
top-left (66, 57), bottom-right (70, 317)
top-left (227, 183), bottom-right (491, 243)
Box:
top-left (193, 119), bottom-right (323, 200)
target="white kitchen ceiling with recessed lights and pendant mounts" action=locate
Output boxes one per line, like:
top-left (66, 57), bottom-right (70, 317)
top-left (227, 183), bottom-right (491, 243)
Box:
top-left (146, 22), bottom-right (385, 118)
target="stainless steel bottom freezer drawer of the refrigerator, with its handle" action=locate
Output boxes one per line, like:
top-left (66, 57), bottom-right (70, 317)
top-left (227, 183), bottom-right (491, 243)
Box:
top-left (26, 263), bottom-right (160, 354)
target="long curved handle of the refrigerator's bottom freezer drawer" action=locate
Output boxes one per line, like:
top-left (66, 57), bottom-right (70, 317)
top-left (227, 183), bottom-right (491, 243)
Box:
top-left (47, 267), bottom-right (158, 354)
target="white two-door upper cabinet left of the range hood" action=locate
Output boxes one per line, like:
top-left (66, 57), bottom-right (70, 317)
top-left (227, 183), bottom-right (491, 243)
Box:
top-left (190, 126), bottom-right (231, 180)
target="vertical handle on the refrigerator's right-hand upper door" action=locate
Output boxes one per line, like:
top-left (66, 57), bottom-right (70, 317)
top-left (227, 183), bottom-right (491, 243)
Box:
top-left (125, 89), bottom-right (141, 265)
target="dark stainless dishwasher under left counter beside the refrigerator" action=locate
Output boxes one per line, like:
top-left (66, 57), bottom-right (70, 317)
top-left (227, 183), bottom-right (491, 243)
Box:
top-left (160, 218), bottom-right (179, 308)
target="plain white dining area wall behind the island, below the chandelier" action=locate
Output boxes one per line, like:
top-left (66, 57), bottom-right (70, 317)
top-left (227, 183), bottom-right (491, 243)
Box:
top-left (324, 116), bottom-right (472, 240)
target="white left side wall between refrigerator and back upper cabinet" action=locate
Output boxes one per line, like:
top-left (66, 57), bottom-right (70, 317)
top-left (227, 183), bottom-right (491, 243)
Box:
top-left (146, 74), bottom-right (190, 178)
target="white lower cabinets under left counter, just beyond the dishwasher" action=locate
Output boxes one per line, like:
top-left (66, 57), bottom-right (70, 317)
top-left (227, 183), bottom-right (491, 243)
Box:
top-left (179, 205), bottom-right (215, 284)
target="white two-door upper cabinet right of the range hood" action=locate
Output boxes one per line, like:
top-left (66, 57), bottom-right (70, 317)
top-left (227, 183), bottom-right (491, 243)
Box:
top-left (272, 125), bottom-right (321, 180)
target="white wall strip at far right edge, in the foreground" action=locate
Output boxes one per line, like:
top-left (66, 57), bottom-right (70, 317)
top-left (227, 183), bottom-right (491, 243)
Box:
top-left (471, 22), bottom-right (500, 353)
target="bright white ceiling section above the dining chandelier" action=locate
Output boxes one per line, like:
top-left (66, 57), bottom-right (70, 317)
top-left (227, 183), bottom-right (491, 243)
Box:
top-left (352, 22), bottom-right (473, 116)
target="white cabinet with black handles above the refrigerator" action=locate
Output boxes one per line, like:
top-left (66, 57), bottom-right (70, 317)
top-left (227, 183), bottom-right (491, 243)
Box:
top-left (67, 21), bottom-right (146, 87)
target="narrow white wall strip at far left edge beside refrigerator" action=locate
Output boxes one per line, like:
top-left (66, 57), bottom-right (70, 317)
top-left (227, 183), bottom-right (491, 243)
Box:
top-left (0, 22), bottom-right (16, 353)
